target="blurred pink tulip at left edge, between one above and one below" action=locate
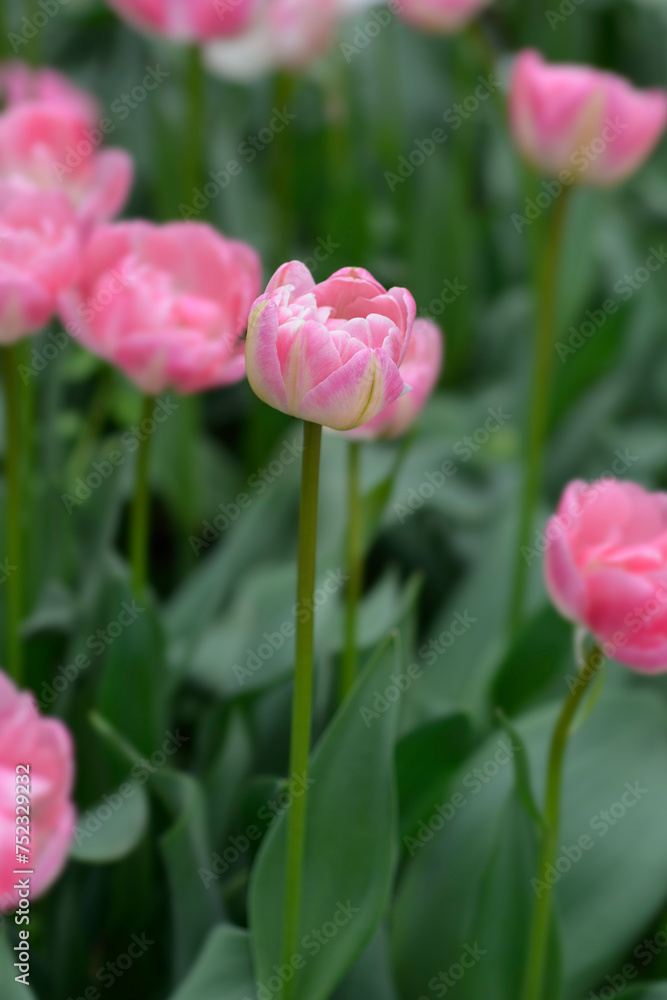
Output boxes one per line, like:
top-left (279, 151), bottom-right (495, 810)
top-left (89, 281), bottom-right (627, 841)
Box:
top-left (0, 101), bottom-right (133, 234)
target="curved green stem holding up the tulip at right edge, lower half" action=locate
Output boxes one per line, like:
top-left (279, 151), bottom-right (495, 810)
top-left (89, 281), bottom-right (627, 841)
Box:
top-left (523, 645), bottom-right (605, 1000)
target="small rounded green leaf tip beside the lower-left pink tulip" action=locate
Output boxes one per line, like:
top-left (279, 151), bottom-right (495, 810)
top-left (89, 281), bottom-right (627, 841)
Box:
top-left (70, 782), bottom-right (148, 865)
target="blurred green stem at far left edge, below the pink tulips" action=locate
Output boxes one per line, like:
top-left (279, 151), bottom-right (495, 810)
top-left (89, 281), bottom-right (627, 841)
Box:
top-left (1, 345), bottom-right (23, 684)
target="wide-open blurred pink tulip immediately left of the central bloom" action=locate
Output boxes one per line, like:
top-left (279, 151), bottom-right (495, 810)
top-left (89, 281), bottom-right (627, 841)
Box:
top-left (60, 222), bottom-right (261, 395)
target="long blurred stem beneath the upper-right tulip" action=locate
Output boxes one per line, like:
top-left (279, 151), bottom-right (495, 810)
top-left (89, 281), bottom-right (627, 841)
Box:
top-left (509, 188), bottom-right (570, 636)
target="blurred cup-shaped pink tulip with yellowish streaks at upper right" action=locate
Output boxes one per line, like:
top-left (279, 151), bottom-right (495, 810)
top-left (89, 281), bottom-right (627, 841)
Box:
top-left (510, 50), bottom-right (667, 184)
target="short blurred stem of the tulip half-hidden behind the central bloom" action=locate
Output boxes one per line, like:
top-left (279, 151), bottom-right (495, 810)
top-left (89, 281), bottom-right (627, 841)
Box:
top-left (340, 441), bottom-right (364, 704)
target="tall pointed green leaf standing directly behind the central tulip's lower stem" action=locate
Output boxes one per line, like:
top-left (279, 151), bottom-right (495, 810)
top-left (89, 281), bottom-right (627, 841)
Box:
top-left (250, 635), bottom-right (398, 1000)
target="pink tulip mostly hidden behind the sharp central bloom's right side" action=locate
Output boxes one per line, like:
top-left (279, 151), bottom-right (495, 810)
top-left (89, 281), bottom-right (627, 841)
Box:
top-left (346, 319), bottom-right (444, 441)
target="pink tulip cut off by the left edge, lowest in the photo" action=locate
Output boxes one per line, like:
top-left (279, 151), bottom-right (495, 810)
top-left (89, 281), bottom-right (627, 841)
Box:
top-left (0, 671), bottom-right (76, 913)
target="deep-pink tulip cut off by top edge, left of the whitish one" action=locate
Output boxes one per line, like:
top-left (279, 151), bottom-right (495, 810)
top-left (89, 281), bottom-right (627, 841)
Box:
top-left (109, 0), bottom-right (258, 42)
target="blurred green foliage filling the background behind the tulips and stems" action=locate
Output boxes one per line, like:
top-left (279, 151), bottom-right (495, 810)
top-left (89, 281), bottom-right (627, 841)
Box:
top-left (0, 0), bottom-right (667, 1000)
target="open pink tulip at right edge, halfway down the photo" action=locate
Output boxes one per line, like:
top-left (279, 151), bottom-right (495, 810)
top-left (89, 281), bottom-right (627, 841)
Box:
top-left (545, 479), bottom-right (667, 673)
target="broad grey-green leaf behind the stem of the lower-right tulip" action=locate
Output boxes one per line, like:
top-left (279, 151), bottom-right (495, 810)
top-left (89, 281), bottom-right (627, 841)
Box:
top-left (393, 692), bottom-right (667, 1000)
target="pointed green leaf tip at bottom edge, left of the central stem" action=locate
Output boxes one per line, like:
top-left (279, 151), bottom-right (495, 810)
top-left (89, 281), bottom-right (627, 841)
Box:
top-left (169, 924), bottom-right (255, 1000)
